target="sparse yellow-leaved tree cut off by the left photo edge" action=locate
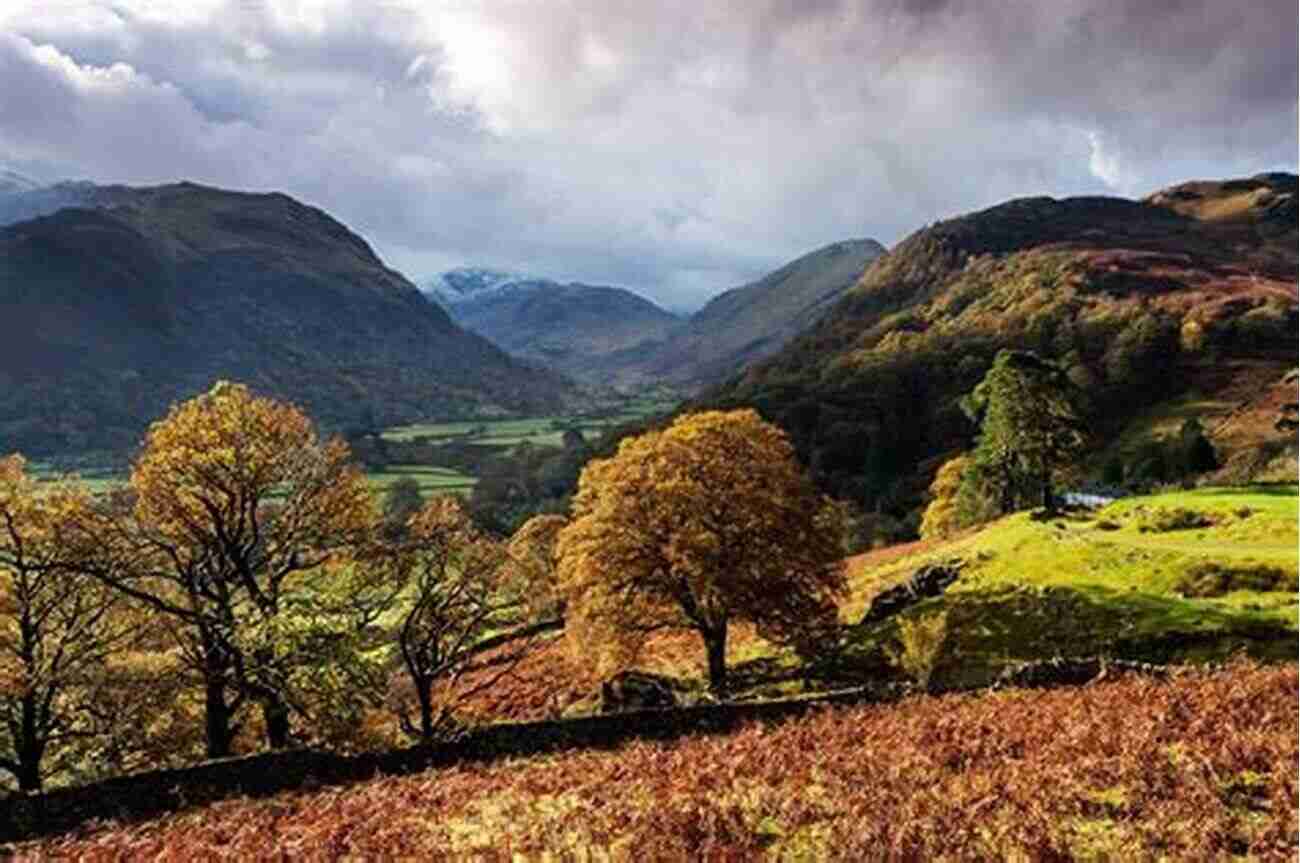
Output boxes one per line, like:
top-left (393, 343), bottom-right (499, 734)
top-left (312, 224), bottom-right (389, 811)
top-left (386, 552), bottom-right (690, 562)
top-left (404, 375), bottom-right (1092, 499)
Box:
top-left (0, 455), bottom-right (140, 792)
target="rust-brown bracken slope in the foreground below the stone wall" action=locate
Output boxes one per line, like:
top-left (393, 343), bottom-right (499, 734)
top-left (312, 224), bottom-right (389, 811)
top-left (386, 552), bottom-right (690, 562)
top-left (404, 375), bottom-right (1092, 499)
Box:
top-left (22, 663), bottom-right (1297, 860)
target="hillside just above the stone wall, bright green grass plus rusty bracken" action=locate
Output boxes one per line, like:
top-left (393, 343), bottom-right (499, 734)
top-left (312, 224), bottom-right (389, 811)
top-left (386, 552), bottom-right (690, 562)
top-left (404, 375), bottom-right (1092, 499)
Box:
top-left (434, 483), bottom-right (1300, 720)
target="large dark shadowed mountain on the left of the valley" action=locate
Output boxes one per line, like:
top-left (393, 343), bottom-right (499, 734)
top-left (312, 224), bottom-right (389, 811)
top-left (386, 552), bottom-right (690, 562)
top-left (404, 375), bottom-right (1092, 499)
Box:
top-left (0, 183), bottom-right (572, 454)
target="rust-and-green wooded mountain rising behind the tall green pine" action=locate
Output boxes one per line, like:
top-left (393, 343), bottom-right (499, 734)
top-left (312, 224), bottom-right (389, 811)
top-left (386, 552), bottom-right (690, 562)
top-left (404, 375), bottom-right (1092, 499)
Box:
top-left (693, 174), bottom-right (1297, 512)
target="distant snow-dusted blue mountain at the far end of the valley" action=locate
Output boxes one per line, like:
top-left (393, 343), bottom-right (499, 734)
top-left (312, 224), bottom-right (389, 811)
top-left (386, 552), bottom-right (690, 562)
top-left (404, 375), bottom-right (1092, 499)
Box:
top-left (424, 269), bottom-right (681, 383)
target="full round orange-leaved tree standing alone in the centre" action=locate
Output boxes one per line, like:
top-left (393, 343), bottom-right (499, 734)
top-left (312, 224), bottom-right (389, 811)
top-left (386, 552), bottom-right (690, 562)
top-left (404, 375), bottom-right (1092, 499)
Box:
top-left (558, 409), bottom-right (844, 691)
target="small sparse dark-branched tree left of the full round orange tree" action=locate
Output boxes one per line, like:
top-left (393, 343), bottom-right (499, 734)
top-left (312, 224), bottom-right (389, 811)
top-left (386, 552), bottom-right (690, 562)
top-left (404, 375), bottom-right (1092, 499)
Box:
top-left (397, 496), bottom-right (562, 742)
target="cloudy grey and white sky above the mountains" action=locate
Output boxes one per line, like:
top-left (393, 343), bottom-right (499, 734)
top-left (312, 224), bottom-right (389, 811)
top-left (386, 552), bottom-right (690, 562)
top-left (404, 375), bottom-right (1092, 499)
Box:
top-left (0, 0), bottom-right (1300, 307)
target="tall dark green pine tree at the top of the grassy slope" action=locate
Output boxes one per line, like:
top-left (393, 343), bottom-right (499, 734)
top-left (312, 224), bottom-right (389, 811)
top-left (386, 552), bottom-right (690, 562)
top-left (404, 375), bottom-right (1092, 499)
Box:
top-left (962, 350), bottom-right (1086, 512)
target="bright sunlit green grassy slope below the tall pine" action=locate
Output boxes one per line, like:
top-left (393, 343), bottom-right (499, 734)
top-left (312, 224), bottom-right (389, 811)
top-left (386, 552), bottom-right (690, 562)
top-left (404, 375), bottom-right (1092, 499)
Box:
top-left (844, 485), bottom-right (1300, 678)
